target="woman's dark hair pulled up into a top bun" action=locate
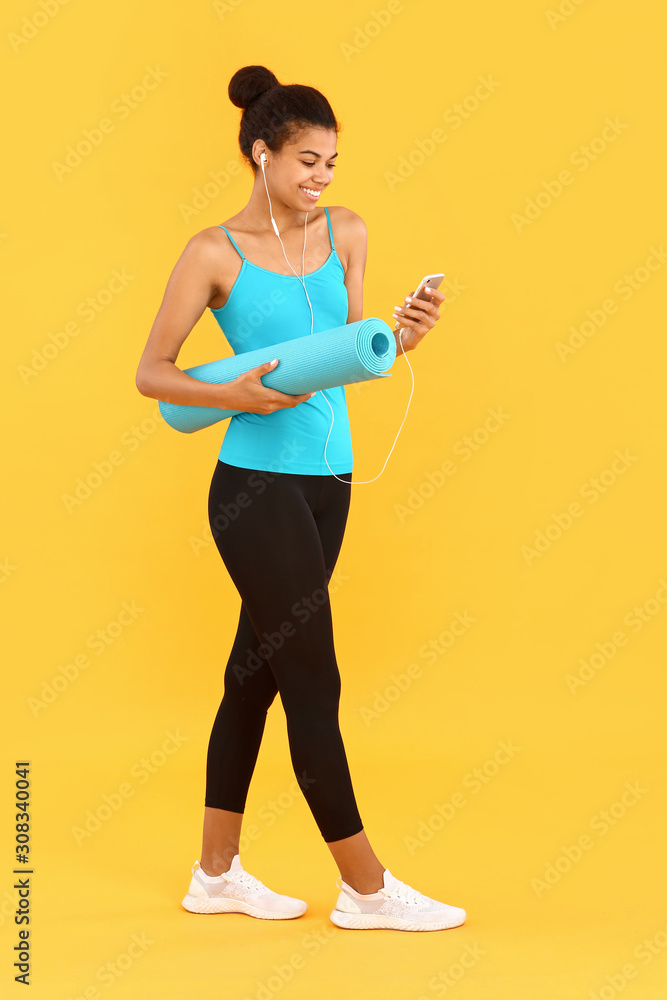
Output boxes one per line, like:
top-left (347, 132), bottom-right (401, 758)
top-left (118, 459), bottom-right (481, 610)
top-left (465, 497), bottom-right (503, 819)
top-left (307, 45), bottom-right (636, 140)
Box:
top-left (228, 66), bottom-right (341, 173)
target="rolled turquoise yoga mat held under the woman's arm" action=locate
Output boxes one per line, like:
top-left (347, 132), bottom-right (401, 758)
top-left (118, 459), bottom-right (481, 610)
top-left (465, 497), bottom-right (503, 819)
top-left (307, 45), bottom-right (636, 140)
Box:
top-left (158, 316), bottom-right (396, 434)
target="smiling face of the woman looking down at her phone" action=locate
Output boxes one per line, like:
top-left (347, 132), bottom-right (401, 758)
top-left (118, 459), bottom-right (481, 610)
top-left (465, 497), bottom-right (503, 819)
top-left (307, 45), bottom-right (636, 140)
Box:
top-left (260, 128), bottom-right (338, 212)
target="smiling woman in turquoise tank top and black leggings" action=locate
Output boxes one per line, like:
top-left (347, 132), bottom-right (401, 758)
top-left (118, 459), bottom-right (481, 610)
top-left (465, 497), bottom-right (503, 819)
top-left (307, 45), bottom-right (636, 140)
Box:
top-left (136, 66), bottom-right (466, 930)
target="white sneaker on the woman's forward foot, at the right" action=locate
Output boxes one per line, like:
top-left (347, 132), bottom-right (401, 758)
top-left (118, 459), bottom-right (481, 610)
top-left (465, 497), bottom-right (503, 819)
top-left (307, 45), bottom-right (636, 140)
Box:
top-left (330, 868), bottom-right (466, 931)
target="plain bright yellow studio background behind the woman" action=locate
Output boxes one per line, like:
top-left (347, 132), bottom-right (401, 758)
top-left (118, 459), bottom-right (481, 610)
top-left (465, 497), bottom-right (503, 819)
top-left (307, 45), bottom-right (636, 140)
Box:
top-left (0, 0), bottom-right (667, 1000)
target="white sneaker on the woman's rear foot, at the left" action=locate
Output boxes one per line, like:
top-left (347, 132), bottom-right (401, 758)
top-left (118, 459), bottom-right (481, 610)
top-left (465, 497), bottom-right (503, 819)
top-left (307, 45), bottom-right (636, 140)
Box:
top-left (183, 854), bottom-right (308, 920)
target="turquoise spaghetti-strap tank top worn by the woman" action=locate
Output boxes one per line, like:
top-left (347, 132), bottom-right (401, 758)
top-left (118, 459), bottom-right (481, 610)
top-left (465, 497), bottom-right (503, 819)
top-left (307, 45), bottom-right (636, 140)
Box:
top-left (211, 207), bottom-right (352, 475)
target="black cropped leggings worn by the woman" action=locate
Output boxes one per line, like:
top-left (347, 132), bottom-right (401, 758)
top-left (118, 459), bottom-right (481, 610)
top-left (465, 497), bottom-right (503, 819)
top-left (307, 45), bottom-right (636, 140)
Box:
top-left (204, 461), bottom-right (363, 842)
